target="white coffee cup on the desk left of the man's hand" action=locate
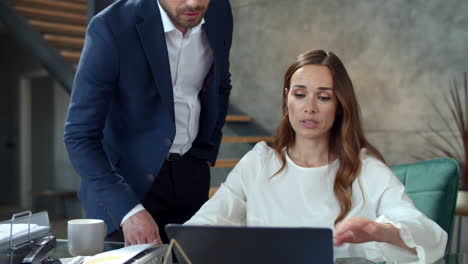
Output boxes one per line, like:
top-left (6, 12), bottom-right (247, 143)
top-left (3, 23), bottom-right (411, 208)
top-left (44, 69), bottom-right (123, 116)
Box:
top-left (68, 219), bottom-right (106, 256)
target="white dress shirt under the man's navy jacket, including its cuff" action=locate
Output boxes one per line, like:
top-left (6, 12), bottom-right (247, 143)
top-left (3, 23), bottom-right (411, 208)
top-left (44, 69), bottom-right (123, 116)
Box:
top-left (121, 1), bottom-right (213, 224)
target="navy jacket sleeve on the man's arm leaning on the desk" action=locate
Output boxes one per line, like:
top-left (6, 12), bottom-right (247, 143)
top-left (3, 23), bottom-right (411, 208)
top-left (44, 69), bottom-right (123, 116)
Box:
top-left (65, 16), bottom-right (139, 225)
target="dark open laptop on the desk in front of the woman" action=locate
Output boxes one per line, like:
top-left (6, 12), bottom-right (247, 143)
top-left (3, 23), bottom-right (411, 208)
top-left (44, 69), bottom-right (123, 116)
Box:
top-left (166, 224), bottom-right (334, 264)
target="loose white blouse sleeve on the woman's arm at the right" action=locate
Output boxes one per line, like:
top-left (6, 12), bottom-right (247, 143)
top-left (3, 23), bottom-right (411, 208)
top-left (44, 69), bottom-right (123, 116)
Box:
top-left (366, 160), bottom-right (447, 263)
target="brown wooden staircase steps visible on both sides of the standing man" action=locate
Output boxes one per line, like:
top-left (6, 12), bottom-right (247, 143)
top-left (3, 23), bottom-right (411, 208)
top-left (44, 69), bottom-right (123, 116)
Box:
top-left (6, 0), bottom-right (273, 196)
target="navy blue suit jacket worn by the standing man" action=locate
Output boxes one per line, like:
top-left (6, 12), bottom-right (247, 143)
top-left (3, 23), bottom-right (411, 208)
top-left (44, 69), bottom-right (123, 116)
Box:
top-left (65, 0), bottom-right (232, 233)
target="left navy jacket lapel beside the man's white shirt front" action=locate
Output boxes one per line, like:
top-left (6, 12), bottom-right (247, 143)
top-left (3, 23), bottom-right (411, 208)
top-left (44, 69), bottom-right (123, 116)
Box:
top-left (136, 0), bottom-right (174, 120)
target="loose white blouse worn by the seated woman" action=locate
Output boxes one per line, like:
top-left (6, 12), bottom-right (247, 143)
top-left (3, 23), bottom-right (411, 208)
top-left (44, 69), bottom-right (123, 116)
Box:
top-left (186, 142), bottom-right (447, 263)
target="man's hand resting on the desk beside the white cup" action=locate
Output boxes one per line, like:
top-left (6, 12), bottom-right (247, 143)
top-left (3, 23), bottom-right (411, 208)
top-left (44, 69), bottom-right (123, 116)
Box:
top-left (122, 210), bottom-right (162, 246)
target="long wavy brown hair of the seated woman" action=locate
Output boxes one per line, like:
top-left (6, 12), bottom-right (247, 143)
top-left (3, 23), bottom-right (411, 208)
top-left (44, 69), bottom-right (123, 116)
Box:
top-left (270, 50), bottom-right (385, 224)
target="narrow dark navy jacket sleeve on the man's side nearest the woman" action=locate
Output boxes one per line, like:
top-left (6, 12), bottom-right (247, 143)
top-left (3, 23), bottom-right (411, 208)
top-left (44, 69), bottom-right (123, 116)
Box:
top-left (208, 1), bottom-right (233, 164)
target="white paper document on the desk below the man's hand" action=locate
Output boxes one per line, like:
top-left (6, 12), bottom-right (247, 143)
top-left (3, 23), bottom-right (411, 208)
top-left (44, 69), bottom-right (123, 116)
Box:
top-left (83, 244), bottom-right (153, 264)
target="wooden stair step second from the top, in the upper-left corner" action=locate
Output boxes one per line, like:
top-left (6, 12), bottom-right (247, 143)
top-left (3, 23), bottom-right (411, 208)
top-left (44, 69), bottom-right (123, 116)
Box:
top-left (15, 5), bottom-right (87, 25)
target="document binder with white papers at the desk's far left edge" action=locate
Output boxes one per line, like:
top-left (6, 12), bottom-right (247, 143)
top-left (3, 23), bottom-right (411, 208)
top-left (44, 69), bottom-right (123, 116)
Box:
top-left (0, 211), bottom-right (51, 264)
